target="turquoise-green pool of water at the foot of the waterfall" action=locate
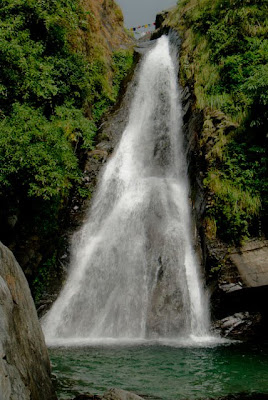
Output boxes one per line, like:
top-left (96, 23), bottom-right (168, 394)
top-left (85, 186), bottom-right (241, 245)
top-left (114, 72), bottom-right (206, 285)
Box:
top-left (50, 344), bottom-right (268, 400)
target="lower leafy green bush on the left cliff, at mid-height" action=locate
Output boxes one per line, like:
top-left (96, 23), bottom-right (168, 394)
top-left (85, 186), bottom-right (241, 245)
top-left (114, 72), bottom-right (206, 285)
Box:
top-left (0, 103), bottom-right (94, 199)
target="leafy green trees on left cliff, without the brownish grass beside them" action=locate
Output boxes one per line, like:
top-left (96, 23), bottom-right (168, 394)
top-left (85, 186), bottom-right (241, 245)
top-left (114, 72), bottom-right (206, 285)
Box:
top-left (0, 0), bottom-right (95, 199)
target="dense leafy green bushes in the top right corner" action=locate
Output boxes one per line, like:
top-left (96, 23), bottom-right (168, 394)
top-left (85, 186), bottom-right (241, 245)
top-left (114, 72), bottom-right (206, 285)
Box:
top-left (192, 0), bottom-right (268, 130)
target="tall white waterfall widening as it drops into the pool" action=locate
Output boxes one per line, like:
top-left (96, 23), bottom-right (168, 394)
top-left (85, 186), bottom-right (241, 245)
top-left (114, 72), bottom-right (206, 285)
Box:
top-left (43, 36), bottom-right (209, 342)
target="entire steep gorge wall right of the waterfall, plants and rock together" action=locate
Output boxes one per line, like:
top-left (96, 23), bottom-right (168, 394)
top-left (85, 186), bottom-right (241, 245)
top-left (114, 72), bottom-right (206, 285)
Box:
top-left (154, 0), bottom-right (268, 338)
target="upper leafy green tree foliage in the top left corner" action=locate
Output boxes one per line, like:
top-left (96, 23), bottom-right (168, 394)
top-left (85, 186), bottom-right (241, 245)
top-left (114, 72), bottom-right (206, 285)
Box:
top-left (0, 0), bottom-right (90, 115)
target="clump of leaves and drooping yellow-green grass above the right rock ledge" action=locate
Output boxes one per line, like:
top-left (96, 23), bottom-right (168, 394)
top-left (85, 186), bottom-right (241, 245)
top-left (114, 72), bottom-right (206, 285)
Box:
top-left (205, 142), bottom-right (268, 243)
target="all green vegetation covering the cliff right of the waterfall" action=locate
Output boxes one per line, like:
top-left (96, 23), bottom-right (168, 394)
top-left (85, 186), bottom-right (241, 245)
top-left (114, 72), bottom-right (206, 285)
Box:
top-left (171, 0), bottom-right (268, 242)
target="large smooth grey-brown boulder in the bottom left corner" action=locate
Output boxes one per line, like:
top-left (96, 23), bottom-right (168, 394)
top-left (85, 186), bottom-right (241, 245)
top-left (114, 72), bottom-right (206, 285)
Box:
top-left (0, 242), bottom-right (56, 400)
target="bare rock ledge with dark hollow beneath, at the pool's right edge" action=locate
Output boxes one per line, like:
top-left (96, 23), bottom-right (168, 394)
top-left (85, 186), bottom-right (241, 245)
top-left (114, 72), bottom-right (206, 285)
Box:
top-left (212, 240), bottom-right (268, 339)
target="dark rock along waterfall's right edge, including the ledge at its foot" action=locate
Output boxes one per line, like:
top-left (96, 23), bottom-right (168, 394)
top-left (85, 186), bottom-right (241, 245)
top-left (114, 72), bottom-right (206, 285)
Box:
top-left (182, 80), bottom-right (268, 340)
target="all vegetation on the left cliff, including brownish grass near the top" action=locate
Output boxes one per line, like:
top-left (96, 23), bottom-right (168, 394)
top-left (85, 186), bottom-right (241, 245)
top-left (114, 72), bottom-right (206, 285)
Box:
top-left (0, 0), bottom-right (133, 300)
